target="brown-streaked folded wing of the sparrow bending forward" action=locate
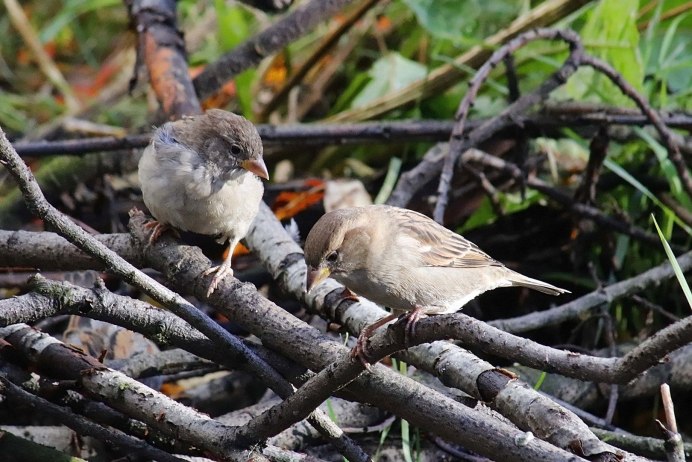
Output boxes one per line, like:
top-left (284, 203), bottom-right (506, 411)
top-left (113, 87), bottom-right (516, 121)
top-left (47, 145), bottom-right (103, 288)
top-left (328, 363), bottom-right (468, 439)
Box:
top-left (390, 209), bottom-right (502, 268)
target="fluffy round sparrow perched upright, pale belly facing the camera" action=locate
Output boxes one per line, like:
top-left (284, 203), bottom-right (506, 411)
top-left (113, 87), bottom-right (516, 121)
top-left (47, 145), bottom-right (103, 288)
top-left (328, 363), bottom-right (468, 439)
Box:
top-left (139, 109), bottom-right (269, 296)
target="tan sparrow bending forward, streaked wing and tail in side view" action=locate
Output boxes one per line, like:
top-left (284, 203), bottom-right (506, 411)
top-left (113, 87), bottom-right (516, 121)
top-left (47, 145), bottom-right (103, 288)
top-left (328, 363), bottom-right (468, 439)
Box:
top-left (304, 205), bottom-right (569, 366)
